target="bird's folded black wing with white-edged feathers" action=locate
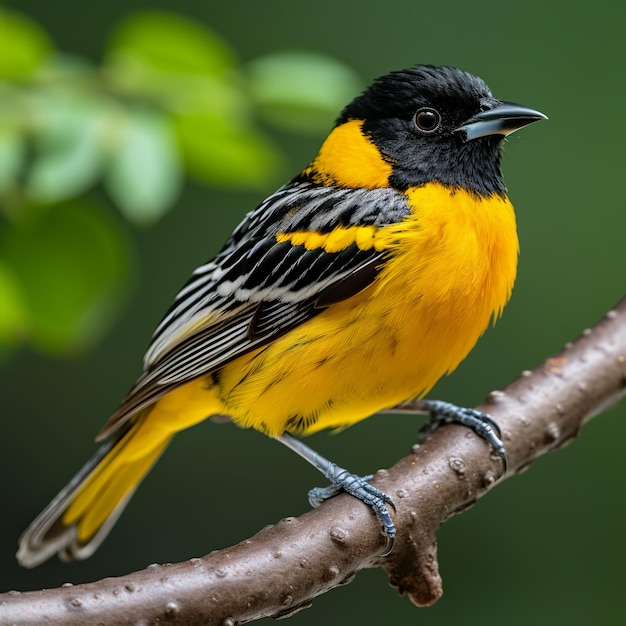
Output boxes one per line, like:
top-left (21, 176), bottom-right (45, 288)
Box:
top-left (99, 179), bottom-right (409, 438)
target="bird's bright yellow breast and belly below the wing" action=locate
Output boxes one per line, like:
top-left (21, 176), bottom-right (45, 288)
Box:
top-left (214, 184), bottom-right (518, 435)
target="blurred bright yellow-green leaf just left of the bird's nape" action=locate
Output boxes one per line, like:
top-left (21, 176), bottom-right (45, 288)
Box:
top-left (176, 115), bottom-right (282, 189)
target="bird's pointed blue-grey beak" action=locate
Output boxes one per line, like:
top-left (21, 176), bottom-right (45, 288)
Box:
top-left (457, 99), bottom-right (548, 141)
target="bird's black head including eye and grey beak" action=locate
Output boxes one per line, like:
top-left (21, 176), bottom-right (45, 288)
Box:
top-left (337, 65), bottom-right (545, 195)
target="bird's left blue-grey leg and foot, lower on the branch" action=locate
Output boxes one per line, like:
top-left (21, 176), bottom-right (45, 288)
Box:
top-left (276, 433), bottom-right (396, 555)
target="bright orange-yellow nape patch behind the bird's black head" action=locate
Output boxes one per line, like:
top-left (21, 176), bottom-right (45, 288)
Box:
top-left (303, 120), bottom-right (392, 189)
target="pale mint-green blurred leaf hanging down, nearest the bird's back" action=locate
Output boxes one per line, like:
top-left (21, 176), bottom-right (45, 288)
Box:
top-left (105, 108), bottom-right (183, 224)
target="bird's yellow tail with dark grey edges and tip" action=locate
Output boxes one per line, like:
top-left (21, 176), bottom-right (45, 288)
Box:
top-left (17, 415), bottom-right (173, 567)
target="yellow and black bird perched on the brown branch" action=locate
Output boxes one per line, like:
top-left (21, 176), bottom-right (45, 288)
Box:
top-left (17, 65), bottom-right (547, 567)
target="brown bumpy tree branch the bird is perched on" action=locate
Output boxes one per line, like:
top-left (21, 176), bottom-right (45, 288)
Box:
top-left (0, 298), bottom-right (626, 626)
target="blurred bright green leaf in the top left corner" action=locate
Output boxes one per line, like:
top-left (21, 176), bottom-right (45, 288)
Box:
top-left (0, 9), bottom-right (52, 79)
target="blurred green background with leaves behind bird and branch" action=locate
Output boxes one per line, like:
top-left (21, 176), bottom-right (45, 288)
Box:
top-left (0, 0), bottom-right (626, 625)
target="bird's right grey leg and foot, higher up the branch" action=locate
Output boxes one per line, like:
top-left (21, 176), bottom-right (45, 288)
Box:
top-left (385, 400), bottom-right (507, 472)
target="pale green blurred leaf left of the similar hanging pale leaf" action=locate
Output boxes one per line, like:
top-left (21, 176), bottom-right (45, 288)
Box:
top-left (26, 93), bottom-right (105, 203)
